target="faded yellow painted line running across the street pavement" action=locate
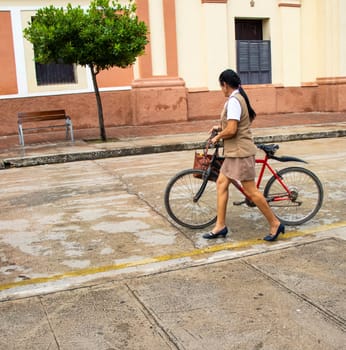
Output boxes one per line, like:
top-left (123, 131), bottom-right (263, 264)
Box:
top-left (0, 221), bottom-right (346, 291)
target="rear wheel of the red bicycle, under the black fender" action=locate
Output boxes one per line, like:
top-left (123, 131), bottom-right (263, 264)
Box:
top-left (263, 167), bottom-right (323, 226)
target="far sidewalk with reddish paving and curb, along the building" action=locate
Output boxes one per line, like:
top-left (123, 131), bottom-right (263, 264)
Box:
top-left (0, 113), bottom-right (346, 169)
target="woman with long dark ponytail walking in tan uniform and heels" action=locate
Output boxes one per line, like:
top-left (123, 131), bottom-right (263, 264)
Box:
top-left (203, 69), bottom-right (285, 241)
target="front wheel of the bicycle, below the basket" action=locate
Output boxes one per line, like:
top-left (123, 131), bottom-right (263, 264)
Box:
top-left (164, 169), bottom-right (216, 229)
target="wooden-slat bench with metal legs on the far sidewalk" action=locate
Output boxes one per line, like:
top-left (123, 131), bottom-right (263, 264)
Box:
top-left (18, 109), bottom-right (74, 146)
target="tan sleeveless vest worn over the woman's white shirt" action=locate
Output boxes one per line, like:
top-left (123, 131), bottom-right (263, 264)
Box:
top-left (221, 93), bottom-right (257, 158)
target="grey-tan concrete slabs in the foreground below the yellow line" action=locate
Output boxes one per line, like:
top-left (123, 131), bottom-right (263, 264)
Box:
top-left (0, 228), bottom-right (346, 350)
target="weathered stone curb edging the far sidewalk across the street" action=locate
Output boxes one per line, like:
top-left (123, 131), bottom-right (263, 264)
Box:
top-left (0, 129), bottom-right (346, 169)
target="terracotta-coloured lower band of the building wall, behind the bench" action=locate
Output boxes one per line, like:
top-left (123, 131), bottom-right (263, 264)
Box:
top-left (0, 81), bottom-right (346, 139)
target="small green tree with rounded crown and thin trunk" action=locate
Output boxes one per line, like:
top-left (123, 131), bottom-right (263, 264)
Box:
top-left (24, 0), bottom-right (148, 141)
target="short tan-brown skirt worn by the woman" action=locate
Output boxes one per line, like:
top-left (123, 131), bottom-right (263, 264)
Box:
top-left (220, 156), bottom-right (256, 181)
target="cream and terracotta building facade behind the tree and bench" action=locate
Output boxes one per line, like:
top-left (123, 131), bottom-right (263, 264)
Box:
top-left (0, 0), bottom-right (346, 136)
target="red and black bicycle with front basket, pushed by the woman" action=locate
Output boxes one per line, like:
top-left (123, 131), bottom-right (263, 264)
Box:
top-left (164, 135), bottom-right (323, 229)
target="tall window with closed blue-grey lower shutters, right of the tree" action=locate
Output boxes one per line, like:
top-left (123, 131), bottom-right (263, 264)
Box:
top-left (235, 19), bottom-right (271, 84)
